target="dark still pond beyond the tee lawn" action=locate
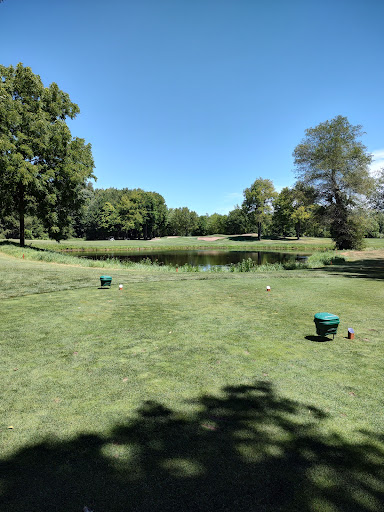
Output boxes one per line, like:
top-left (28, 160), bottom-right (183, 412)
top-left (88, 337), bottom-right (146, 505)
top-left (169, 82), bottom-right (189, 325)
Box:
top-left (72, 249), bottom-right (308, 270)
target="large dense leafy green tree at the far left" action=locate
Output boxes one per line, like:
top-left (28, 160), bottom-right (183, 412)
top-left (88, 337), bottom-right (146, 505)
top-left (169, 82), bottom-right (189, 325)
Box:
top-left (0, 63), bottom-right (94, 246)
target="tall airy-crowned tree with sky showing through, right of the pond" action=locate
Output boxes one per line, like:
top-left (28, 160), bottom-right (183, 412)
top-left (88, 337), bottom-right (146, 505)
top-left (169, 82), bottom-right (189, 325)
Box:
top-left (293, 116), bottom-right (374, 249)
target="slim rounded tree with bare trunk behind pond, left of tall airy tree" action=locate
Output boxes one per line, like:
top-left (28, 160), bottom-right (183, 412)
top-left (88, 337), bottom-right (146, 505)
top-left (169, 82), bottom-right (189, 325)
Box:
top-left (242, 178), bottom-right (277, 240)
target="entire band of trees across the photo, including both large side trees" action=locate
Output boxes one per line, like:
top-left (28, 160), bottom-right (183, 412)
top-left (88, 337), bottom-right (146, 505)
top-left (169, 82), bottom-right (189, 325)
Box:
top-left (0, 63), bottom-right (384, 249)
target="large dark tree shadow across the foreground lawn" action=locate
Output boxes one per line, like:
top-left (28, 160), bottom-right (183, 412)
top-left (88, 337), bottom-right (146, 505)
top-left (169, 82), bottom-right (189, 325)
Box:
top-left (0, 382), bottom-right (384, 512)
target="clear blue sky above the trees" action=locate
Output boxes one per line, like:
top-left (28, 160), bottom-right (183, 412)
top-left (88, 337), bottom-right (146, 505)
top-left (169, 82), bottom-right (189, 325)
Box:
top-left (0, 0), bottom-right (384, 215)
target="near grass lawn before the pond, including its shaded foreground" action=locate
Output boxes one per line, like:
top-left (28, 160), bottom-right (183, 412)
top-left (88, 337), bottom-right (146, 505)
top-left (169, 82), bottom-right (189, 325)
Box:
top-left (0, 246), bottom-right (384, 512)
